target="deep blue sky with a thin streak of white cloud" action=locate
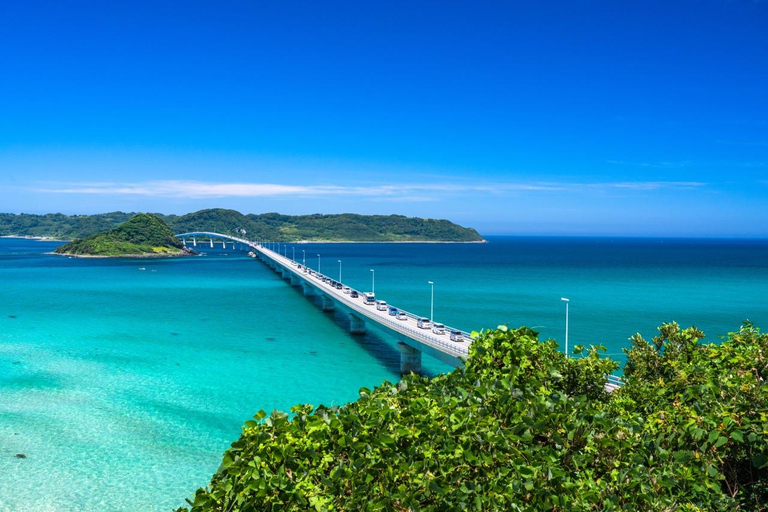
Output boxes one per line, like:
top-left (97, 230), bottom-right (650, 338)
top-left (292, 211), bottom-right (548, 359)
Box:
top-left (0, 0), bottom-right (768, 237)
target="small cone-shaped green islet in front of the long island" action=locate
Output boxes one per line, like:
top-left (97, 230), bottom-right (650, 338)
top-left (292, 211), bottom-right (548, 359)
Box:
top-left (55, 213), bottom-right (195, 258)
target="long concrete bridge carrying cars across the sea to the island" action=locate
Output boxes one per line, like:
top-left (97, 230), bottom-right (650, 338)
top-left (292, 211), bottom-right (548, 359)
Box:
top-left (176, 231), bottom-right (623, 392)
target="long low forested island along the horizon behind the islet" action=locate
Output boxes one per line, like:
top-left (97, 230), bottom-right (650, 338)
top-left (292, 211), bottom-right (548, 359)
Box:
top-left (0, 208), bottom-right (483, 242)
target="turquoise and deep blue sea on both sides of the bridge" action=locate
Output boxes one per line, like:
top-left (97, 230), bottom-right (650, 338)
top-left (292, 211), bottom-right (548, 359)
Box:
top-left (0, 237), bottom-right (768, 512)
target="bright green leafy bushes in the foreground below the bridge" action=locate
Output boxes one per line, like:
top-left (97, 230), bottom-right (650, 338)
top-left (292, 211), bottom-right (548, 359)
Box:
top-left (177, 323), bottom-right (768, 512)
